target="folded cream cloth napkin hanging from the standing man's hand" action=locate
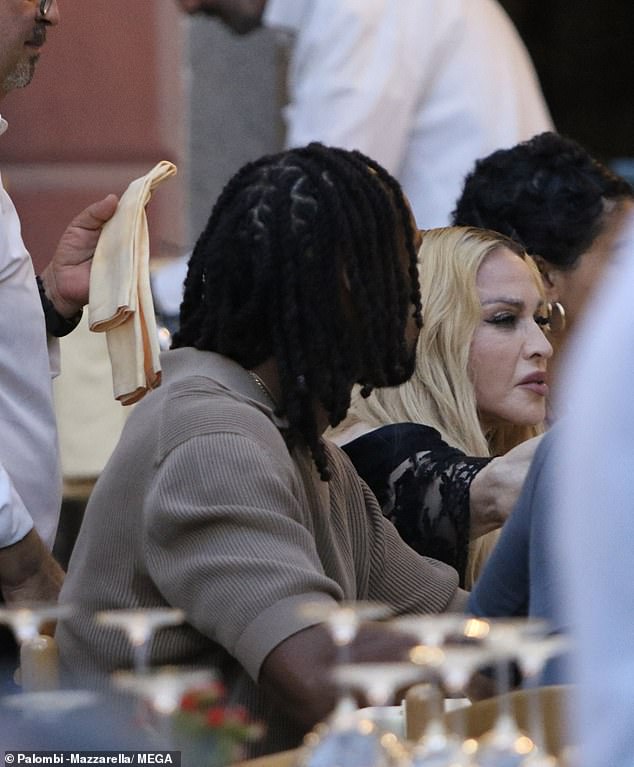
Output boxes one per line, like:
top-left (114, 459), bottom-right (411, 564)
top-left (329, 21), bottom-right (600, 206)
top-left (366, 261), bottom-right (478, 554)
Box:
top-left (88, 160), bottom-right (176, 405)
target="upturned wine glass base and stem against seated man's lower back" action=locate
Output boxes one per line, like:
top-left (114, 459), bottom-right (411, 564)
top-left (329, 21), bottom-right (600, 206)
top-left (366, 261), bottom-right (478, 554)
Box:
top-left (95, 607), bottom-right (185, 674)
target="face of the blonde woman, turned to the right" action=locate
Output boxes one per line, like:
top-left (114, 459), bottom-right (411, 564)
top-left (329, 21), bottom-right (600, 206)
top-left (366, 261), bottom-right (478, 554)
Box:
top-left (469, 246), bottom-right (553, 431)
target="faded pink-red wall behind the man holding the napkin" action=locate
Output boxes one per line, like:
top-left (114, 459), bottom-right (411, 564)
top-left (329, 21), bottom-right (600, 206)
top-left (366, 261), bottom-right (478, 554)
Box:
top-left (0, 0), bottom-right (186, 268)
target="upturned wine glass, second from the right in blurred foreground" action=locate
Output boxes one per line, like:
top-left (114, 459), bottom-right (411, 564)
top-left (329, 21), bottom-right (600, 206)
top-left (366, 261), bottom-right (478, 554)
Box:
top-left (470, 618), bottom-right (548, 767)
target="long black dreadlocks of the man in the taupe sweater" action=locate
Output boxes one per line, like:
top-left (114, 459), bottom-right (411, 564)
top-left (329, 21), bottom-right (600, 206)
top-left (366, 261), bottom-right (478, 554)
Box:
top-left (172, 143), bottom-right (421, 480)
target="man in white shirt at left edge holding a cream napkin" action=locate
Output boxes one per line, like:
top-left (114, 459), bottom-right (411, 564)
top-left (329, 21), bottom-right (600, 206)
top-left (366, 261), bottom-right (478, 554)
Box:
top-left (0, 0), bottom-right (117, 602)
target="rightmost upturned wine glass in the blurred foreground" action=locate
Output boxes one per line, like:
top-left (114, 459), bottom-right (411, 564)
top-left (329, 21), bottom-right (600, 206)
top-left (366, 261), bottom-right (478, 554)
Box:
top-left (518, 634), bottom-right (571, 767)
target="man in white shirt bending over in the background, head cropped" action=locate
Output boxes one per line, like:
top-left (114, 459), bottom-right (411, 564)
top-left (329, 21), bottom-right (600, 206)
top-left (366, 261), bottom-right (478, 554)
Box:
top-left (178, 0), bottom-right (553, 228)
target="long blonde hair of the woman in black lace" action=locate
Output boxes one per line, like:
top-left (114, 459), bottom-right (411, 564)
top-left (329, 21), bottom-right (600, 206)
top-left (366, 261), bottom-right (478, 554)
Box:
top-left (337, 227), bottom-right (545, 456)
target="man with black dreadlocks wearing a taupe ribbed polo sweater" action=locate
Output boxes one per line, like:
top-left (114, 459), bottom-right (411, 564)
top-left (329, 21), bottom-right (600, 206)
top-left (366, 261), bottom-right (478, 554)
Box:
top-left (57, 144), bottom-right (464, 752)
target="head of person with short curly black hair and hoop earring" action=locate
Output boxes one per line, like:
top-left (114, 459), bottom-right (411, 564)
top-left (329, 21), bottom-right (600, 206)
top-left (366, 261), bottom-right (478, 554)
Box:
top-left (452, 132), bottom-right (634, 345)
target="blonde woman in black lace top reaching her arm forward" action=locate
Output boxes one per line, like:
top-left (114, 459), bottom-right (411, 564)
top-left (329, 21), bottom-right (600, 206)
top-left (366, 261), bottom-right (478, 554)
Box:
top-left (333, 227), bottom-right (552, 588)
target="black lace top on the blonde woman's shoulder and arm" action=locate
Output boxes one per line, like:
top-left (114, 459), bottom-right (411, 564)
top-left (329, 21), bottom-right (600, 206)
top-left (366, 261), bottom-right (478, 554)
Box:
top-left (343, 423), bottom-right (491, 584)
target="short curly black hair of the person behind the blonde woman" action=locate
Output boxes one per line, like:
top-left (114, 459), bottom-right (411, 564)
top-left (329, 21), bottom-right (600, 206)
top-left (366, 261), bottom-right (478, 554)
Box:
top-left (452, 132), bottom-right (634, 269)
